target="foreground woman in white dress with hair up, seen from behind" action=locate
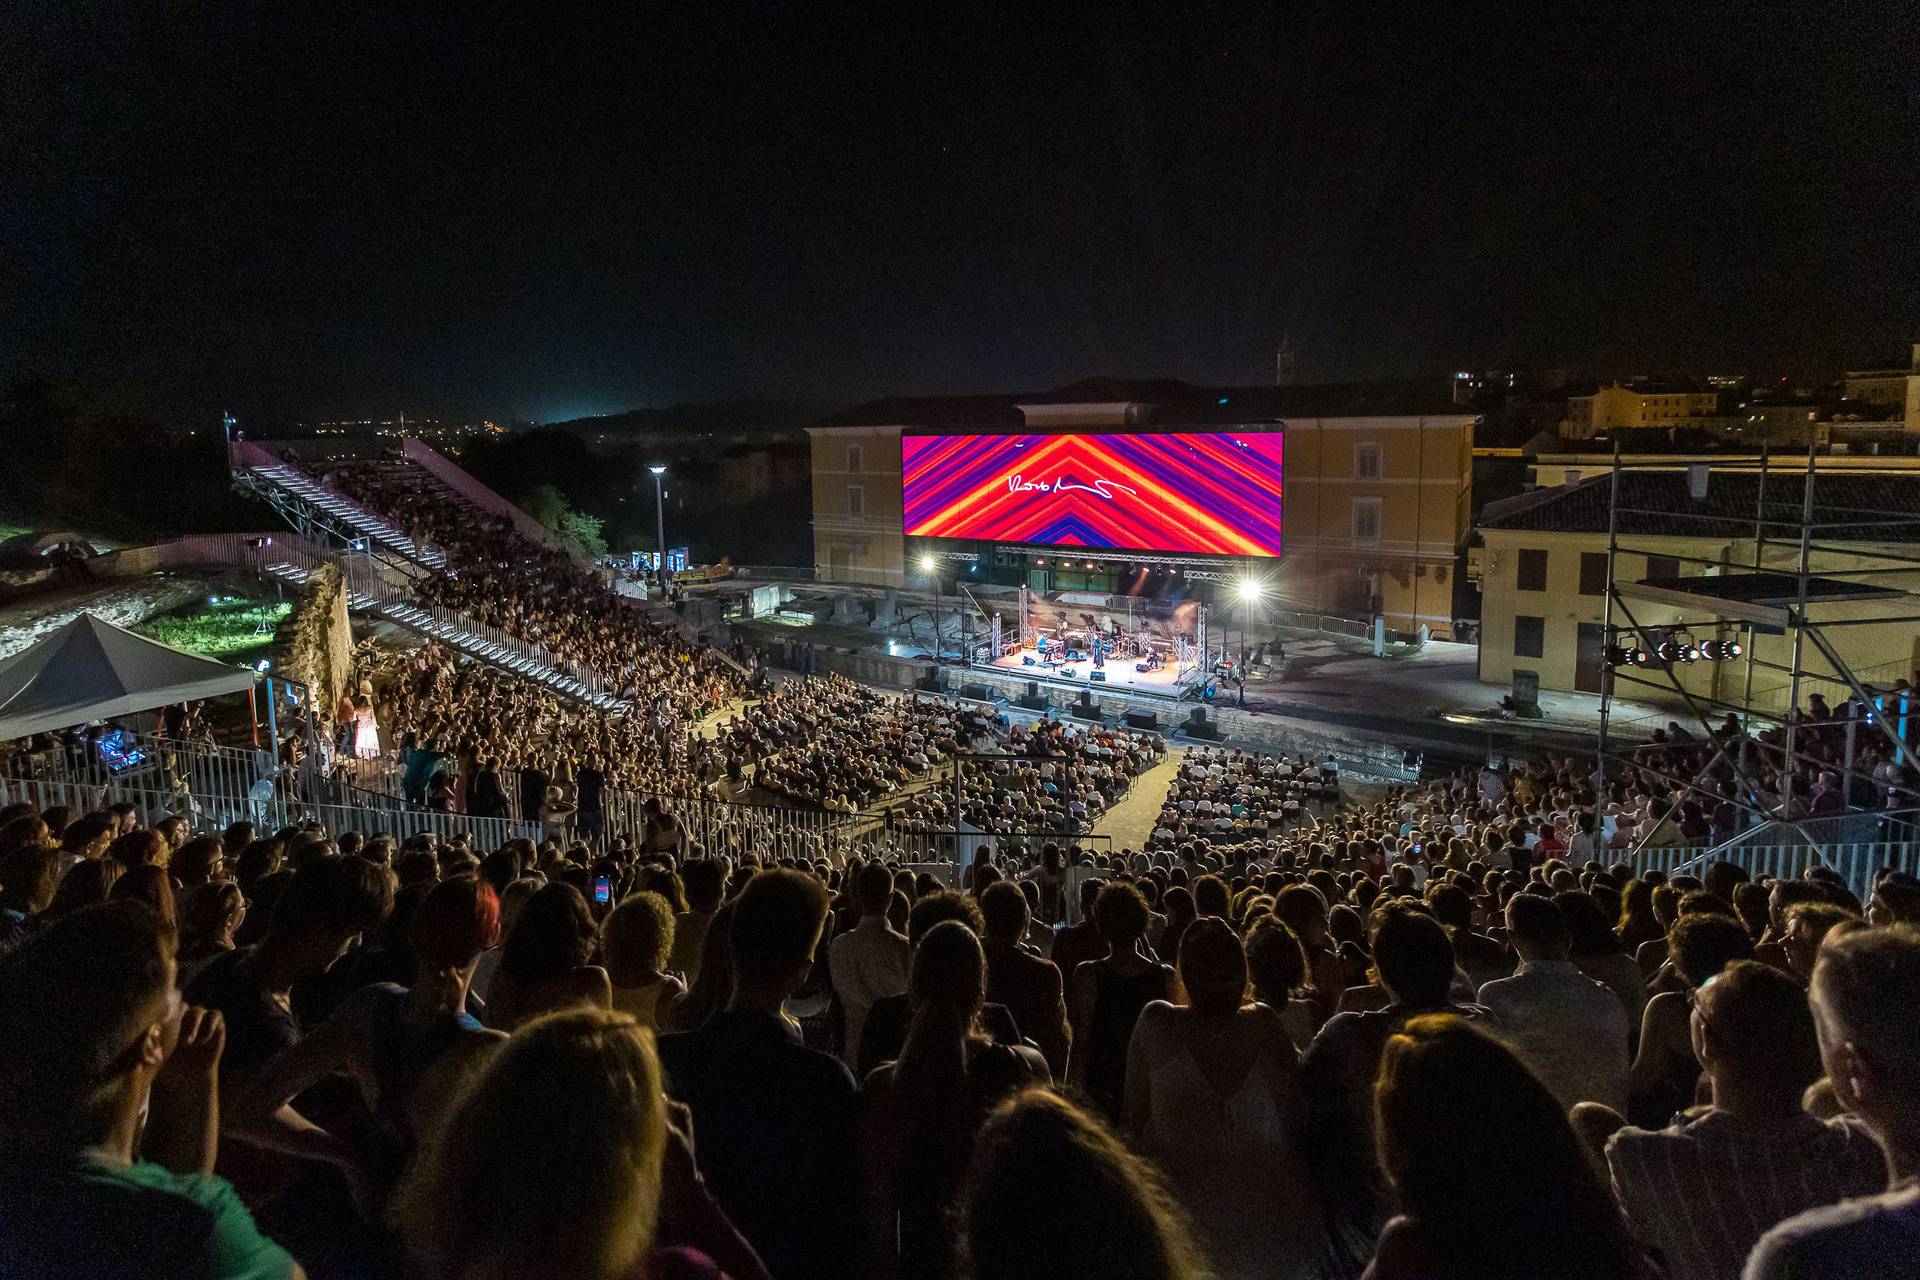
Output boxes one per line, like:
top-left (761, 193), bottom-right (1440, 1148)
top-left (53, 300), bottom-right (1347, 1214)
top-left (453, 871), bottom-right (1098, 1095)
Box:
top-left (1127, 917), bottom-right (1327, 1280)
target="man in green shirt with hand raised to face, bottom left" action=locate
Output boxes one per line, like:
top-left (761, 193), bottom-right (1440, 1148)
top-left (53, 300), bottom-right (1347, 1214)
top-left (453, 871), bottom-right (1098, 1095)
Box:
top-left (0, 900), bottom-right (303, 1280)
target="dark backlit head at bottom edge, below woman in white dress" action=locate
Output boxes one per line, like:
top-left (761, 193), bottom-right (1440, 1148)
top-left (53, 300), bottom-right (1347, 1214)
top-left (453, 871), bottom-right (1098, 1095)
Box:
top-left (960, 1090), bottom-right (1213, 1280)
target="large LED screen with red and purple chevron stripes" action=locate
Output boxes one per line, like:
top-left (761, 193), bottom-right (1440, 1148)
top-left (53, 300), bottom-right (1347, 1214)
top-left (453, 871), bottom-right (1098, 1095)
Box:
top-left (900, 432), bottom-right (1281, 557)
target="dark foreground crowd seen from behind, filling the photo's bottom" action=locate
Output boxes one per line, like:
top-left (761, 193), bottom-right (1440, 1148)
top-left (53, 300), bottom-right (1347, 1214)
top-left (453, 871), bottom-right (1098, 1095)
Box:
top-left (0, 775), bottom-right (1920, 1280)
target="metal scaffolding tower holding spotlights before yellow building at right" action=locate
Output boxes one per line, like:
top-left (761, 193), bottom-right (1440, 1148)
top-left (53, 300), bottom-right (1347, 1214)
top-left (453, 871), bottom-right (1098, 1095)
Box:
top-left (1596, 439), bottom-right (1920, 852)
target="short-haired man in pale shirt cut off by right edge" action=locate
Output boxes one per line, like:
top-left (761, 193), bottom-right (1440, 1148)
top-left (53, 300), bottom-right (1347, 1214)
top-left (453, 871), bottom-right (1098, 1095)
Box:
top-left (1743, 925), bottom-right (1920, 1280)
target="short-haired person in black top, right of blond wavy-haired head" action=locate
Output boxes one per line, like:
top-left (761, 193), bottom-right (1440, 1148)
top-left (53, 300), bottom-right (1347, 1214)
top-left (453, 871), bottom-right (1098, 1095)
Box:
top-left (660, 871), bottom-right (858, 1280)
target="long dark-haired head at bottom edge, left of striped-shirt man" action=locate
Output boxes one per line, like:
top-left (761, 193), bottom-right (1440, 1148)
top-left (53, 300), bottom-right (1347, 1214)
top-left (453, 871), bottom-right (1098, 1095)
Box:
top-left (1367, 1020), bottom-right (1655, 1280)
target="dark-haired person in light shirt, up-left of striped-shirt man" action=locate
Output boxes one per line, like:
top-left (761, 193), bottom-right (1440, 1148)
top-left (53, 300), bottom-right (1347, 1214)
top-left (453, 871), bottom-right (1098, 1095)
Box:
top-left (1480, 892), bottom-right (1632, 1111)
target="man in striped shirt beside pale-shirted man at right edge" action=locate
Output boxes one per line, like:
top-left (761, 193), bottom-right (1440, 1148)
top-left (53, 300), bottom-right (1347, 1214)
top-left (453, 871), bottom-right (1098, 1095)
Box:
top-left (1607, 960), bottom-right (1887, 1280)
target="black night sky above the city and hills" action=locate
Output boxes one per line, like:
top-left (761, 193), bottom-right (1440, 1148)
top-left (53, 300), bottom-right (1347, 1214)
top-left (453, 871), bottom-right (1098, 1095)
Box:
top-left (0, 0), bottom-right (1920, 420)
